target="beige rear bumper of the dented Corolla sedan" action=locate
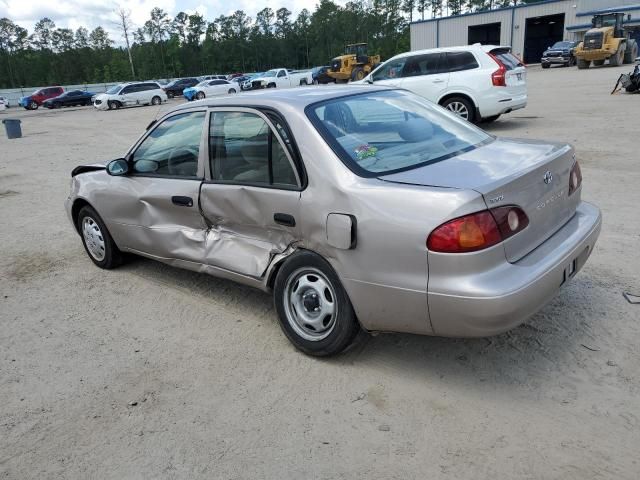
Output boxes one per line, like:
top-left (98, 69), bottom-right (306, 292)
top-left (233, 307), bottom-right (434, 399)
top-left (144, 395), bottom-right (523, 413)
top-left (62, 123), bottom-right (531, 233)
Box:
top-left (427, 202), bottom-right (602, 337)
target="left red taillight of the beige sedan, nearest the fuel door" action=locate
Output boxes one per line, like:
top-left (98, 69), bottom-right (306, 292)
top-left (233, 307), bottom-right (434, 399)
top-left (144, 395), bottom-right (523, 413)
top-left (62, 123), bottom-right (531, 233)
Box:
top-left (427, 206), bottom-right (529, 253)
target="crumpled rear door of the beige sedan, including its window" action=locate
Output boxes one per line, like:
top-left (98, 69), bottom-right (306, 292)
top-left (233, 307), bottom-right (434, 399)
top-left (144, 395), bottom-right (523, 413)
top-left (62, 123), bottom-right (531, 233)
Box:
top-left (200, 107), bottom-right (302, 278)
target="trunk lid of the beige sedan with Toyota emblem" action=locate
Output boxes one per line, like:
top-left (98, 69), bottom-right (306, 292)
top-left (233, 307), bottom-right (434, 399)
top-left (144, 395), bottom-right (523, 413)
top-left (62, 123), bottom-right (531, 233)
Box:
top-left (379, 139), bottom-right (580, 262)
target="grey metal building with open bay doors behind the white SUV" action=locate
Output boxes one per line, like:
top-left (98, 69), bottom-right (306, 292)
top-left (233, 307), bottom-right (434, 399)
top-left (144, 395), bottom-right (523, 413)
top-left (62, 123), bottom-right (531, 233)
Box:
top-left (411, 0), bottom-right (640, 63)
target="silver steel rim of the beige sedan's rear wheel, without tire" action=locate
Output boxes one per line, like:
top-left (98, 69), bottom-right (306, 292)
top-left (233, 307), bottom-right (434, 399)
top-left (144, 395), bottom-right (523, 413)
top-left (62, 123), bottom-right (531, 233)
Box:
top-left (283, 267), bottom-right (338, 342)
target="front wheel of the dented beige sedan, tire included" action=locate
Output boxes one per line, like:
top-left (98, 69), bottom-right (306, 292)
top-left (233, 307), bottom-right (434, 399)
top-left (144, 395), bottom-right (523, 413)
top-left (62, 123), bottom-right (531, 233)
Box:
top-left (78, 205), bottom-right (122, 269)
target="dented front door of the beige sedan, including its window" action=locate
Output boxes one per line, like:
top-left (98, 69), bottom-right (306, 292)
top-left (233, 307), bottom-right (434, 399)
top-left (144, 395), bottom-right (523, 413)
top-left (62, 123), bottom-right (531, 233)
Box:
top-left (100, 109), bottom-right (207, 263)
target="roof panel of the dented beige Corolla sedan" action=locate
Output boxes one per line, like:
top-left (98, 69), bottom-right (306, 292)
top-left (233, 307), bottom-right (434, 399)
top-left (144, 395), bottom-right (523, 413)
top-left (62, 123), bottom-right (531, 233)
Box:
top-left (167, 85), bottom-right (394, 113)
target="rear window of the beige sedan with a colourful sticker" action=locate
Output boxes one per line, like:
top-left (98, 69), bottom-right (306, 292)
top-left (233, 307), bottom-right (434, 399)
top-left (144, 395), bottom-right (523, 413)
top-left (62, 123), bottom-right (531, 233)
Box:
top-left (307, 90), bottom-right (493, 177)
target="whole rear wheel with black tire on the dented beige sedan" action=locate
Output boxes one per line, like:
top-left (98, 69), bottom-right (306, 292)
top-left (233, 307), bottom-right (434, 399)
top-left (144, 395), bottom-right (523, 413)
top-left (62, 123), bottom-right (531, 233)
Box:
top-left (273, 251), bottom-right (360, 357)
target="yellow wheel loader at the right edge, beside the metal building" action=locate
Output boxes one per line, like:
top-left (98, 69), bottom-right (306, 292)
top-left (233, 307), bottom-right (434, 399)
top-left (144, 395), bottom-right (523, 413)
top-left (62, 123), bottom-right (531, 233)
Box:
top-left (575, 12), bottom-right (638, 69)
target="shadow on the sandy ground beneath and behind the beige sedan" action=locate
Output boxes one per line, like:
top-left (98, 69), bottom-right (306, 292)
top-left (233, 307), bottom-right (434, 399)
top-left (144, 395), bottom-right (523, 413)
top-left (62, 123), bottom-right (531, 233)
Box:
top-left (121, 257), bottom-right (606, 385)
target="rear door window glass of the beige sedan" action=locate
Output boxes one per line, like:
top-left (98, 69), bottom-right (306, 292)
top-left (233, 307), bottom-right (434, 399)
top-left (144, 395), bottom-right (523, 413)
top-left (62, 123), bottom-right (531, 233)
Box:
top-left (209, 112), bottom-right (298, 188)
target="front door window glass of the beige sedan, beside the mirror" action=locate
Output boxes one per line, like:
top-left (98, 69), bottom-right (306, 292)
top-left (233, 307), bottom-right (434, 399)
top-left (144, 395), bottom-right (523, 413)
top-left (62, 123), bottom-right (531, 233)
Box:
top-left (132, 112), bottom-right (205, 178)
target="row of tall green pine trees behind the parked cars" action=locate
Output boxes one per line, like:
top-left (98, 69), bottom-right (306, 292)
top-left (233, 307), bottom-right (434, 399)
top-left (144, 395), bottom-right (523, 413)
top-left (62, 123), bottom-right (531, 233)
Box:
top-left (0, 0), bottom-right (540, 88)
